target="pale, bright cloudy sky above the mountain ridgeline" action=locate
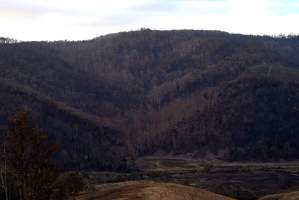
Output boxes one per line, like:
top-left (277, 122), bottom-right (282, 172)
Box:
top-left (0, 0), bottom-right (299, 41)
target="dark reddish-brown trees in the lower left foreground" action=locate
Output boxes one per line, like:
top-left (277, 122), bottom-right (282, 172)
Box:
top-left (0, 111), bottom-right (84, 200)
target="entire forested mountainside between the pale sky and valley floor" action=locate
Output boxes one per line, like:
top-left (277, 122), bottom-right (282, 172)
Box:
top-left (0, 29), bottom-right (299, 168)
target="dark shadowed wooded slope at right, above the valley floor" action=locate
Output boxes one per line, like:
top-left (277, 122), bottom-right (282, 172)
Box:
top-left (161, 78), bottom-right (299, 160)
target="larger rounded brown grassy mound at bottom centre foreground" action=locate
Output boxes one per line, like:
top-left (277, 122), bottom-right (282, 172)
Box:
top-left (77, 181), bottom-right (237, 200)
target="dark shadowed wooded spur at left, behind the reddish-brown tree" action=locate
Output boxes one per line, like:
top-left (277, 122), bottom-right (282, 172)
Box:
top-left (0, 79), bottom-right (127, 170)
